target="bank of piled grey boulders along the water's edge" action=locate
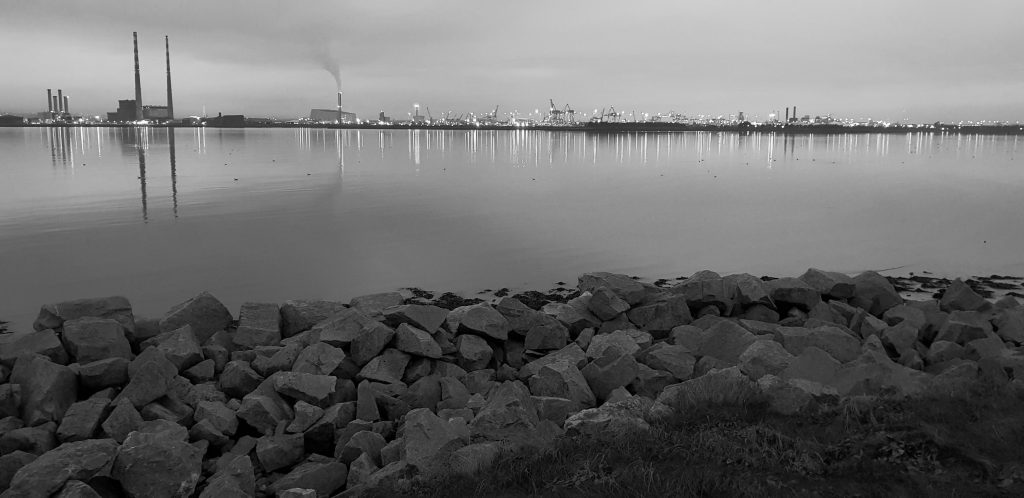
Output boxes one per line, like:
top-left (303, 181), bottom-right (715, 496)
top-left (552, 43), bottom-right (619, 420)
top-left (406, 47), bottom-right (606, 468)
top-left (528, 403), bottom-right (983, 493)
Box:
top-left (0, 268), bottom-right (1024, 498)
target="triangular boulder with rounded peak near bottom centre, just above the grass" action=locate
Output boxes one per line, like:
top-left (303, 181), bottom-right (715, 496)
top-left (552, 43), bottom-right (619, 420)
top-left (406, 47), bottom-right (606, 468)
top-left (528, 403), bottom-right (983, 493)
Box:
top-left (468, 380), bottom-right (540, 437)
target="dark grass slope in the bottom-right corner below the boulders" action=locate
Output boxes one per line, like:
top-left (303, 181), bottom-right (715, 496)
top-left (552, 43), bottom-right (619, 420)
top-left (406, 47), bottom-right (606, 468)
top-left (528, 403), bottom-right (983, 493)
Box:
top-left (370, 386), bottom-right (1024, 497)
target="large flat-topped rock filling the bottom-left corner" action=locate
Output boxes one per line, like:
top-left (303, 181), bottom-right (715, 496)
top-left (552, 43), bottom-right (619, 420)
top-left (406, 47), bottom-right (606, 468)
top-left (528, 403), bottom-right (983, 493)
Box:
top-left (0, 440), bottom-right (118, 498)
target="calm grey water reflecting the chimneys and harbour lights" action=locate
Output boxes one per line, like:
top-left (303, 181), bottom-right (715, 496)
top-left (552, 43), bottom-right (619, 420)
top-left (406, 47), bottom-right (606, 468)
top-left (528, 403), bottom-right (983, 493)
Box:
top-left (0, 128), bottom-right (1024, 330)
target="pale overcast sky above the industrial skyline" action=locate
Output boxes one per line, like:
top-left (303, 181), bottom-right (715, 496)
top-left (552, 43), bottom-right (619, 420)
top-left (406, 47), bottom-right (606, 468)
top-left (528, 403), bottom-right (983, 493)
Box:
top-left (0, 0), bottom-right (1024, 123)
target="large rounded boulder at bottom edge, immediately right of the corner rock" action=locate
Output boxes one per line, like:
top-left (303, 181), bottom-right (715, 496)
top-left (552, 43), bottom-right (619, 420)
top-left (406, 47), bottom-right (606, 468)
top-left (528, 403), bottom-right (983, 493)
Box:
top-left (111, 432), bottom-right (203, 498)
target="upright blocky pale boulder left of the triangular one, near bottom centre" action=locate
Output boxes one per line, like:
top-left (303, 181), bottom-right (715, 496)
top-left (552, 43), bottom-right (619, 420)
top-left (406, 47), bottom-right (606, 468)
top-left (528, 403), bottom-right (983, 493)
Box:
top-left (403, 408), bottom-right (468, 475)
